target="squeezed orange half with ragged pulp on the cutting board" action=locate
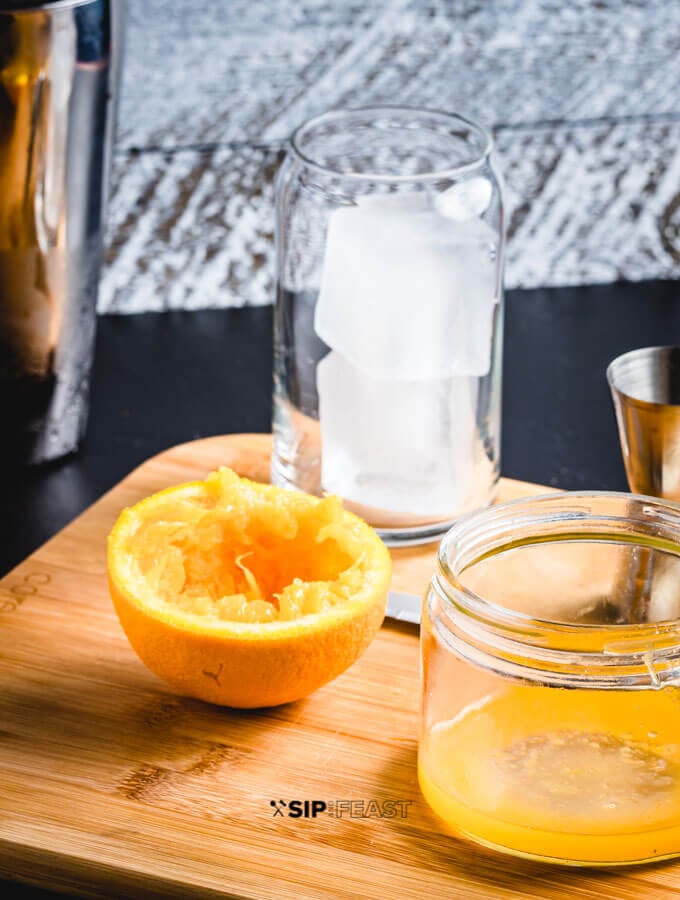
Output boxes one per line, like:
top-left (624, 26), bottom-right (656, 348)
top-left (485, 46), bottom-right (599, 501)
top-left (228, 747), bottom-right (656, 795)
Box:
top-left (107, 469), bottom-right (391, 707)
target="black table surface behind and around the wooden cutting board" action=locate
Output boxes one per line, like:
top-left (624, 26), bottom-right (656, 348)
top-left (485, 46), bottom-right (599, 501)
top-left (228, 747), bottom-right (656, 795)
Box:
top-left (0, 281), bottom-right (680, 897)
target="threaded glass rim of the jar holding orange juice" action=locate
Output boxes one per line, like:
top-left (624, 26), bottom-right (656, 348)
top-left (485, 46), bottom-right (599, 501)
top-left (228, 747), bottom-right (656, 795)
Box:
top-left (431, 491), bottom-right (680, 687)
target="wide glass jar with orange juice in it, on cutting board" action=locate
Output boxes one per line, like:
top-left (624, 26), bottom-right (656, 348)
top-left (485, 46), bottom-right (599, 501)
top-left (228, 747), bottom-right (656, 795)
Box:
top-left (418, 492), bottom-right (680, 865)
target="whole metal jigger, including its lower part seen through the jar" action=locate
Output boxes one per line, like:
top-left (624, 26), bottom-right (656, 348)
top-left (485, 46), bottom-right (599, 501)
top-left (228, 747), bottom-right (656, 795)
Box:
top-left (607, 347), bottom-right (680, 622)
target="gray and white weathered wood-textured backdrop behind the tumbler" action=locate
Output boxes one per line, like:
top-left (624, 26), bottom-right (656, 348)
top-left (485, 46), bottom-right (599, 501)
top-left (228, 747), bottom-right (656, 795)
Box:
top-left (100, 0), bottom-right (680, 312)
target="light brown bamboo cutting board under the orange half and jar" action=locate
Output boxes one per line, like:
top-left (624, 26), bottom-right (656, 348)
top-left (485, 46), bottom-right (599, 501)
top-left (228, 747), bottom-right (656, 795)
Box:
top-left (0, 435), bottom-right (680, 900)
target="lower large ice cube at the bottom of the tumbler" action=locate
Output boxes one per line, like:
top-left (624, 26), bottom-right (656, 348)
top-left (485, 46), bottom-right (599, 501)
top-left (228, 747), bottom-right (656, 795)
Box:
top-left (317, 352), bottom-right (484, 520)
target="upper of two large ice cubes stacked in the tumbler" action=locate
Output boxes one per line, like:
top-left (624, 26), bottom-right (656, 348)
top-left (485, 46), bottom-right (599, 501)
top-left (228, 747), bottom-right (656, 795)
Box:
top-left (314, 194), bottom-right (497, 381)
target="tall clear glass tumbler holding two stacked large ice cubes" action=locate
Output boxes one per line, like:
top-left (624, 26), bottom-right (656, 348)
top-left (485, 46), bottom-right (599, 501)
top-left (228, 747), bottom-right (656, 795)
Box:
top-left (272, 107), bottom-right (504, 545)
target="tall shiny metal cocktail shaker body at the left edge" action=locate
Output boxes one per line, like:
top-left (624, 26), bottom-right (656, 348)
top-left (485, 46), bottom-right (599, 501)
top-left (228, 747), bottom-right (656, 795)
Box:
top-left (0, 0), bottom-right (125, 463)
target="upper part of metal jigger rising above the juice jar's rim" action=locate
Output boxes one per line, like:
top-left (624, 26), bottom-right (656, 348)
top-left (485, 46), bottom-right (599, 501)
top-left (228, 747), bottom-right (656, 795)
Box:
top-left (607, 347), bottom-right (680, 502)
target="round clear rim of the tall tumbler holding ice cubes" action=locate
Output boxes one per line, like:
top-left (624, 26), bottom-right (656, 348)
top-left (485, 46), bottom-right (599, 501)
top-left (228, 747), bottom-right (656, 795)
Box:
top-left (289, 104), bottom-right (494, 184)
